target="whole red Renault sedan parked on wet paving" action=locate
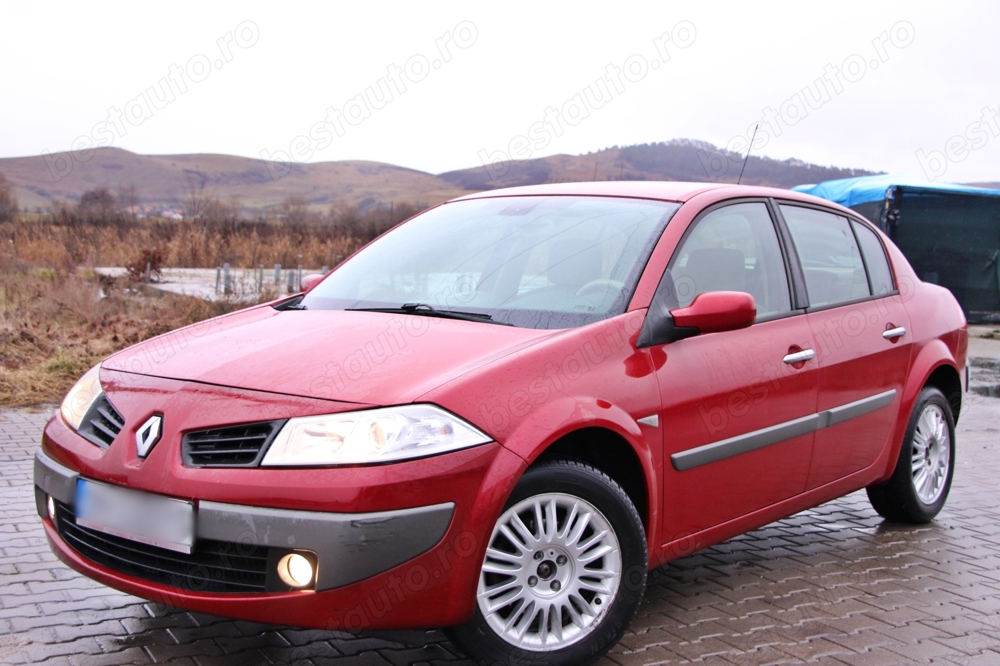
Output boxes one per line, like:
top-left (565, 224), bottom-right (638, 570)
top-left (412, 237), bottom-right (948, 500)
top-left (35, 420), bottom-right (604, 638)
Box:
top-left (35, 182), bottom-right (967, 664)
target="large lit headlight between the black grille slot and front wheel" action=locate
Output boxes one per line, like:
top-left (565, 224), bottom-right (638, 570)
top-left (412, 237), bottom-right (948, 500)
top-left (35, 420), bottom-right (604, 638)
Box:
top-left (261, 405), bottom-right (491, 466)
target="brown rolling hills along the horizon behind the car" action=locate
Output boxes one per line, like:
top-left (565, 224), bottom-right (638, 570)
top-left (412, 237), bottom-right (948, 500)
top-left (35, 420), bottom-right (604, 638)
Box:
top-left (0, 139), bottom-right (872, 210)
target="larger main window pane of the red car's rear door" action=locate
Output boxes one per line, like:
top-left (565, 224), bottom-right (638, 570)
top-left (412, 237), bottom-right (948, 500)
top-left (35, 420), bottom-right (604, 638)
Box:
top-left (781, 205), bottom-right (871, 307)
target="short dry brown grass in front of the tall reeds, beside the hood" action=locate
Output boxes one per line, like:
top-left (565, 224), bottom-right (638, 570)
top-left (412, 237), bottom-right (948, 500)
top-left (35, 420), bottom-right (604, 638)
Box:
top-left (0, 258), bottom-right (266, 407)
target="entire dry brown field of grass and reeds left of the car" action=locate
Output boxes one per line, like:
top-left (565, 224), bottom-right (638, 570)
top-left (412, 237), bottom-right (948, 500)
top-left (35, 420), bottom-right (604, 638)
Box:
top-left (0, 207), bottom-right (413, 407)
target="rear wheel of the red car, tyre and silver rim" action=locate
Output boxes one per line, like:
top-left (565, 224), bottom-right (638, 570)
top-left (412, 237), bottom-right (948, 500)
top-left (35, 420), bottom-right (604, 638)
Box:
top-left (868, 387), bottom-right (955, 524)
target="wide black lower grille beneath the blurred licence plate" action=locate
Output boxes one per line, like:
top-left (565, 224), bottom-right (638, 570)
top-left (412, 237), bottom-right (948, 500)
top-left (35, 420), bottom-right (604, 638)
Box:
top-left (56, 503), bottom-right (269, 592)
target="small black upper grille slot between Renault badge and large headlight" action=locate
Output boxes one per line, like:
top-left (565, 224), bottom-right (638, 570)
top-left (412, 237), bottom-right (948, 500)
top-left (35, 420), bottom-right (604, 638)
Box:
top-left (181, 420), bottom-right (285, 467)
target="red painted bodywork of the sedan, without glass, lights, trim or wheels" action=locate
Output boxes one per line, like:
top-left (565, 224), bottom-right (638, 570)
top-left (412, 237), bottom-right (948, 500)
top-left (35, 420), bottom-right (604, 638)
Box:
top-left (43, 183), bottom-right (967, 631)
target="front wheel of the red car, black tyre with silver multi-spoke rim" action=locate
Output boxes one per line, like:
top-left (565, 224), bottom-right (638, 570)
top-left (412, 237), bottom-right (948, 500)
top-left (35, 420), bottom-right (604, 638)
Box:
top-left (448, 460), bottom-right (648, 666)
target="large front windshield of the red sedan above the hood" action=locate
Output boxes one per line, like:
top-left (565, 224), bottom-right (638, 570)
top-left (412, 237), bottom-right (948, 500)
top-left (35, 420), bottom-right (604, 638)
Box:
top-left (302, 196), bottom-right (680, 328)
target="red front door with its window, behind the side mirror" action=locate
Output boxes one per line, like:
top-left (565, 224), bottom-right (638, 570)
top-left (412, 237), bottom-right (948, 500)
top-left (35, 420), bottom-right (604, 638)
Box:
top-left (650, 200), bottom-right (818, 542)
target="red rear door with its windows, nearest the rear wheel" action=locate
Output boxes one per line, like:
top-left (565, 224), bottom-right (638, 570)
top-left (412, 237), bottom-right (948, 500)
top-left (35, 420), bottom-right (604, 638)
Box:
top-left (779, 203), bottom-right (911, 488)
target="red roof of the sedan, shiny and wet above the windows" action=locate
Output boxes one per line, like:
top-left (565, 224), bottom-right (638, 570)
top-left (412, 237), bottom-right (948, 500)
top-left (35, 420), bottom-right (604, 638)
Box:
top-left (452, 180), bottom-right (856, 215)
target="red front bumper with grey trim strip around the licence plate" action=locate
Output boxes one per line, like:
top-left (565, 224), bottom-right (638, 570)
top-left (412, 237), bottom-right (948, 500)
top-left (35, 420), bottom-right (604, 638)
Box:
top-left (35, 373), bottom-right (526, 631)
